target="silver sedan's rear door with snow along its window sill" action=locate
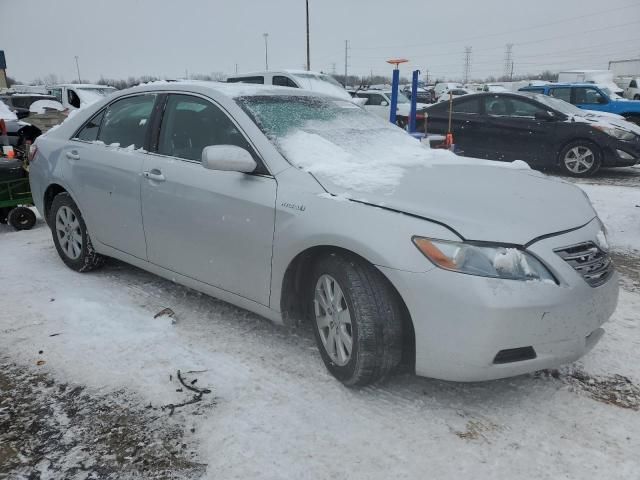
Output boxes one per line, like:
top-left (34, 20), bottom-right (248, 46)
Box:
top-left (66, 94), bottom-right (156, 259)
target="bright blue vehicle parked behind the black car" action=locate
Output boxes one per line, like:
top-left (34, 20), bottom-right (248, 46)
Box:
top-left (520, 83), bottom-right (640, 125)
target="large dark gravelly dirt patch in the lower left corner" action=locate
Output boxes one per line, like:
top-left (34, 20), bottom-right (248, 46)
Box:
top-left (0, 362), bottom-right (206, 480)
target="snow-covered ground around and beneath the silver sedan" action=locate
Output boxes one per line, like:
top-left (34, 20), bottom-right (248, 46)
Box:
top-left (0, 172), bottom-right (640, 480)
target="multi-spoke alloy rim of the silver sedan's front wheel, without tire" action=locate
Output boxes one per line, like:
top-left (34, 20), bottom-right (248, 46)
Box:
top-left (313, 274), bottom-right (353, 366)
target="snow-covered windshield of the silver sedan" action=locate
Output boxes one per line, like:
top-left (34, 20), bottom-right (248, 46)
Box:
top-left (236, 95), bottom-right (436, 191)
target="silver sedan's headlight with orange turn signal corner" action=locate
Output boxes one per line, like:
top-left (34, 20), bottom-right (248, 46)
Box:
top-left (412, 237), bottom-right (556, 283)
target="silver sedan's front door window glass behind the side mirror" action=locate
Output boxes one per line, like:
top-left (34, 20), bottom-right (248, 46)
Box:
top-left (158, 94), bottom-right (259, 167)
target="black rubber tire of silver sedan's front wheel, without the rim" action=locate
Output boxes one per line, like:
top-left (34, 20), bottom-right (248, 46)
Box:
top-left (309, 254), bottom-right (404, 386)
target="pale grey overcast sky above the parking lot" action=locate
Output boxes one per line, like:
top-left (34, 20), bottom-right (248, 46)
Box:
top-left (0, 0), bottom-right (640, 82)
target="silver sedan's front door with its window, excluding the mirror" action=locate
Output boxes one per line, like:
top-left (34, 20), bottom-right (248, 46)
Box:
top-left (142, 94), bottom-right (277, 305)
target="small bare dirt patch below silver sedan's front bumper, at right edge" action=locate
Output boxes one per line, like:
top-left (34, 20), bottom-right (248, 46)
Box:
top-left (535, 368), bottom-right (640, 410)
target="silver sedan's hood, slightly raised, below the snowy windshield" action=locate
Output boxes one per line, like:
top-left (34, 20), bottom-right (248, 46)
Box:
top-left (314, 161), bottom-right (596, 245)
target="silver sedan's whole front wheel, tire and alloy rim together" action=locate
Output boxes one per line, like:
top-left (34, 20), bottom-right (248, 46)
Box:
top-left (310, 254), bottom-right (403, 386)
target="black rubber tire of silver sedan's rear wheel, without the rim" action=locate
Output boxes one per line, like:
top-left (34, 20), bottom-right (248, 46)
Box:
top-left (48, 193), bottom-right (105, 272)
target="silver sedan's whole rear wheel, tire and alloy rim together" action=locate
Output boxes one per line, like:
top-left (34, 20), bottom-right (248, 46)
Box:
top-left (49, 193), bottom-right (104, 272)
